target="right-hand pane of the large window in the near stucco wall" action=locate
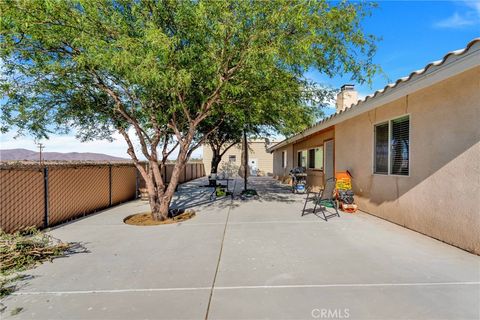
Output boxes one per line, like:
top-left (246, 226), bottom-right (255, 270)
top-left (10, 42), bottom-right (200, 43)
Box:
top-left (390, 116), bottom-right (410, 176)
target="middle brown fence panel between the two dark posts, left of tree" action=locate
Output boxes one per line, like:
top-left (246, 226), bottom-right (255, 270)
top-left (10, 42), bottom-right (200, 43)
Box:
top-left (49, 166), bottom-right (110, 225)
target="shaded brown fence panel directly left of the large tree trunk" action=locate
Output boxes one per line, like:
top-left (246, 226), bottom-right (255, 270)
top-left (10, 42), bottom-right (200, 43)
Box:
top-left (112, 166), bottom-right (137, 204)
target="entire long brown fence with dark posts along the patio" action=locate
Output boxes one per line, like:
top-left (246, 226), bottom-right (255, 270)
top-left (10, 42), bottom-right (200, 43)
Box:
top-left (0, 163), bottom-right (205, 232)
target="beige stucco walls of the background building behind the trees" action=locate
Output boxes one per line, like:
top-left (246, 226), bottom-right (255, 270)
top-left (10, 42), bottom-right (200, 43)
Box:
top-left (203, 140), bottom-right (273, 175)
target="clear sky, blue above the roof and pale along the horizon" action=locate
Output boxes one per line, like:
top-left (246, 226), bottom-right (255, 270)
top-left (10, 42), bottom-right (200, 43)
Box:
top-left (0, 0), bottom-right (480, 157)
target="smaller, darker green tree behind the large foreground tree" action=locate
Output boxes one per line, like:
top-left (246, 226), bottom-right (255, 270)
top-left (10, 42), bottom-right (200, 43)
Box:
top-left (199, 70), bottom-right (334, 178)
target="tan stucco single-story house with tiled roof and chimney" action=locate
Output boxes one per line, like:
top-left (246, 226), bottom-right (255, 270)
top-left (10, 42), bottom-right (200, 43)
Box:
top-left (269, 38), bottom-right (480, 254)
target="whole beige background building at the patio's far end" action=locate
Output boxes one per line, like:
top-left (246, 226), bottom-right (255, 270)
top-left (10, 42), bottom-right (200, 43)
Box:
top-left (203, 139), bottom-right (276, 176)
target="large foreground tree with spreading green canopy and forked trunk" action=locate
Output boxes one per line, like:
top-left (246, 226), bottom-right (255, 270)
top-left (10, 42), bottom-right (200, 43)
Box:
top-left (0, 0), bottom-right (376, 219)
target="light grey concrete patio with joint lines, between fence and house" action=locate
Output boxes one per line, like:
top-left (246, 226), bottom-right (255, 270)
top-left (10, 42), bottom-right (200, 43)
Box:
top-left (0, 178), bottom-right (480, 319)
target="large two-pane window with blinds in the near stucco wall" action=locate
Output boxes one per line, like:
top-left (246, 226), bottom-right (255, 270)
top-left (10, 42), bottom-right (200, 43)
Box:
top-left (374, 116), bottom-right (410, 176)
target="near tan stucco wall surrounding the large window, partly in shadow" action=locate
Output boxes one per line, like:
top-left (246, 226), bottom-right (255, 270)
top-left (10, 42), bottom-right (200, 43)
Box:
top-left (335, 67), bottom-right (480, 254)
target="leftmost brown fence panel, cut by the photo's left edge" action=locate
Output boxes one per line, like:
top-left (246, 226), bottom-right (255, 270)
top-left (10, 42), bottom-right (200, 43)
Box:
top-left (0, 168), bottom-right (45, 232)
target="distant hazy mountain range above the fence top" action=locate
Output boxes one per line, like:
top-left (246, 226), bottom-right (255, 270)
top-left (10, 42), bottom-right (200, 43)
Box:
top-left (0, 149), bottom-right (129, 161)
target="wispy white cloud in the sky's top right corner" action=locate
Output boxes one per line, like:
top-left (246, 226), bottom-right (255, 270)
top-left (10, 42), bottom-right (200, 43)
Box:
top-left (433, 0), bottom-right (480, 29)
